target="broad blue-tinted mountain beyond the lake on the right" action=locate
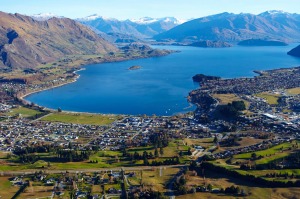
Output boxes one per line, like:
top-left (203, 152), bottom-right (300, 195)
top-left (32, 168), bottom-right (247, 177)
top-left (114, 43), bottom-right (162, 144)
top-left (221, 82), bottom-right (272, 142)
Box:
top-left (154, 11), bottom-right (300, 42)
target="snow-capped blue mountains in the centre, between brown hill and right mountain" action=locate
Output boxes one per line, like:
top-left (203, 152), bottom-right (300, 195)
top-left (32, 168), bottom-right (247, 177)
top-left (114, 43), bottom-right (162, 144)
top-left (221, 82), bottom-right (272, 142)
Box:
top-left (77, 14), bottom-right (184, 38)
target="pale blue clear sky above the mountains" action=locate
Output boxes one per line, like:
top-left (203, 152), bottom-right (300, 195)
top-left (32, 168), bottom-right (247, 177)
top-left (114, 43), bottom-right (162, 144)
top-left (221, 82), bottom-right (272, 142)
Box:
top-left (0, 0), bottom-right (300, 19)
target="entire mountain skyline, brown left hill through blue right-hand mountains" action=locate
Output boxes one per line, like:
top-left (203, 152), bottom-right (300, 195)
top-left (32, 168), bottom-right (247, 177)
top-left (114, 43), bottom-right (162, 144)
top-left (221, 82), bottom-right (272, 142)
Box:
top-left (0, 11), bottom-right (300, 70)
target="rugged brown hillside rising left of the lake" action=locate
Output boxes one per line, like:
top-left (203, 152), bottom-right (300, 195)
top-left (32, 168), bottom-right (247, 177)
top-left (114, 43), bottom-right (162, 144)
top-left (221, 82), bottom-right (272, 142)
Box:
top-left (0, 12), bottom-right (117, 70)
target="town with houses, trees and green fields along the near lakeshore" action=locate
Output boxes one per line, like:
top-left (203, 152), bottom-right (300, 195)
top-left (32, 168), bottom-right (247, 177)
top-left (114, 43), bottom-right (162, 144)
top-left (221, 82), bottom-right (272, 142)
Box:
top-left (0, 68), bottom-right (300, 198)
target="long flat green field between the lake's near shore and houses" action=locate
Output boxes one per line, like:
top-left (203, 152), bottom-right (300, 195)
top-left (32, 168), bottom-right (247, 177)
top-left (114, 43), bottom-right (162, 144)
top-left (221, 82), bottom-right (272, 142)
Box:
top-left (41, 113), bottom-right (121, 125)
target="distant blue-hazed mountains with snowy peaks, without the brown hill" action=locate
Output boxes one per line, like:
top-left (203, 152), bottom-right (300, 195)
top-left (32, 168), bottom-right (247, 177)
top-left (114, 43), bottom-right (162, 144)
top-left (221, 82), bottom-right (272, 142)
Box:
top-left (33, 10), bottom-right (300, 43)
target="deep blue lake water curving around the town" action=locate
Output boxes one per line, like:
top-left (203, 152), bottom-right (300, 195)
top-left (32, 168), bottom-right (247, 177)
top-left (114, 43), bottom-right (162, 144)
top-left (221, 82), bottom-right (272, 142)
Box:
top-left (26, 44), bottom-right (300, 115)
